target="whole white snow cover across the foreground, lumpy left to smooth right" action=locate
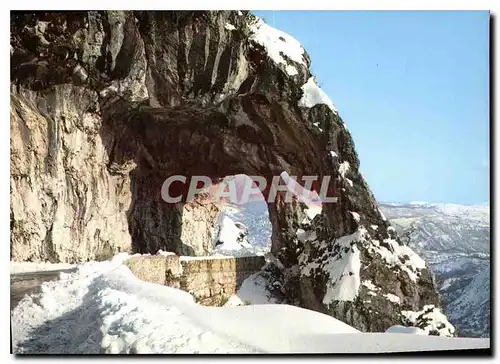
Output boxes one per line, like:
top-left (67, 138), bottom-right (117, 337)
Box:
top-left (12, 254), bottom-right (490, 354)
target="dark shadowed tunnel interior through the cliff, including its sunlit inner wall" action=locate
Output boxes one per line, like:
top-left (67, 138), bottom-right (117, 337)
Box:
top-left (100, 95), bottom-right (330, 261)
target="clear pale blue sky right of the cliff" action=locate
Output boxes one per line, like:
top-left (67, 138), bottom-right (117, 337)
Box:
top-left (253, 11), bottom-right (490, 204)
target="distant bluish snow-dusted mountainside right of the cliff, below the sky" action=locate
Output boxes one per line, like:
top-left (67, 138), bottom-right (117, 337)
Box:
top-left (380, 202), bottom-right (490, 337)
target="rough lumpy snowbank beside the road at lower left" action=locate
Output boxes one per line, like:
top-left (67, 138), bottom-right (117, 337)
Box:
top-left (12, 262), bottom-right (252, 354)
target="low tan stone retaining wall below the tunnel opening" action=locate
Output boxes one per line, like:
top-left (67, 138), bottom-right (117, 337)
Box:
top-left (125, 255), bottom-right (265, 306)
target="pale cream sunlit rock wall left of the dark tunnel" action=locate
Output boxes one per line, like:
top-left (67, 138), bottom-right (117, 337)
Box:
top-left (10, 84), bottom-right (131, 263)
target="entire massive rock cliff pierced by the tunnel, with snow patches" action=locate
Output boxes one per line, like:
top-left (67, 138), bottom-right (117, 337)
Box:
top-left (11, 11), bottom-right (449, 331)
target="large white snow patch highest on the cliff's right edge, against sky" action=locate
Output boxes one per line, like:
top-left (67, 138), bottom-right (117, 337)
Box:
top-left (250, 18), bottom-right (306, 76)
